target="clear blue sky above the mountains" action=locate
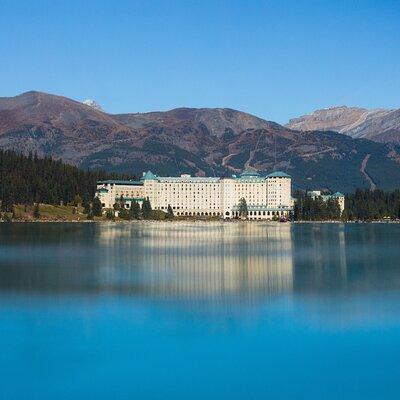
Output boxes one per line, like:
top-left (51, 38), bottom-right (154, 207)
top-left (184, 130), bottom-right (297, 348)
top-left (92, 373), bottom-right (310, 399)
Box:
top-left (0, 0), bottom-right (400, 123)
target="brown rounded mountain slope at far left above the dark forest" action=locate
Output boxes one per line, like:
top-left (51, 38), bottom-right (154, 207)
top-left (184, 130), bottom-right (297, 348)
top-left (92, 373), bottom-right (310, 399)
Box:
top-left (0, 92), bottom-right (131, 165)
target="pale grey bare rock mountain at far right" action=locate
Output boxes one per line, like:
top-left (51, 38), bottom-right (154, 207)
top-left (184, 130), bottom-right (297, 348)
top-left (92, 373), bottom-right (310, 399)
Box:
top-left (286, 106), bottom-right (400, 144)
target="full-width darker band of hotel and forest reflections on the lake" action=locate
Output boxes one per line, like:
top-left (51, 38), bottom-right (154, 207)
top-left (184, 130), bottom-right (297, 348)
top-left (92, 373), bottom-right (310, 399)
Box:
top-left (0, 222), bottom-right (400, 300)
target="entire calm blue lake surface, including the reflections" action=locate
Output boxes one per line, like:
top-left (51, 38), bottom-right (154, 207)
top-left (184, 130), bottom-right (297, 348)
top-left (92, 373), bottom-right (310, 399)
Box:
top-left (0, 223), bottom-right (400, 400)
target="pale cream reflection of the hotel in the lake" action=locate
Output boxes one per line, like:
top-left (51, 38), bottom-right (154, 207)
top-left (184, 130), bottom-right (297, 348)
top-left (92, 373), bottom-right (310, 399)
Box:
top-left (98, 223), bottom-right (293, 298)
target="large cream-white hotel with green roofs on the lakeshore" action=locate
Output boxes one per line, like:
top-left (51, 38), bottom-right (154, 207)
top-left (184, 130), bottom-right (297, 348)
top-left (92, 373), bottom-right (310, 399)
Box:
top-left (97, 171), bottom-right (293, 219)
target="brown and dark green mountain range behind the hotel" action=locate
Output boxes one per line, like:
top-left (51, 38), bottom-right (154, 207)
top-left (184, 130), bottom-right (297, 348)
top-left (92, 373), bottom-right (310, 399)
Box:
top-left (0, 91), bottom-right (400, 192)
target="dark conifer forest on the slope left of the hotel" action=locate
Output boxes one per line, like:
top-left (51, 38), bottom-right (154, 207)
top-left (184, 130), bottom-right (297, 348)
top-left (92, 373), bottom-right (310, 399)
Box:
top-left (0, 150), bottom-right (132, 211)
